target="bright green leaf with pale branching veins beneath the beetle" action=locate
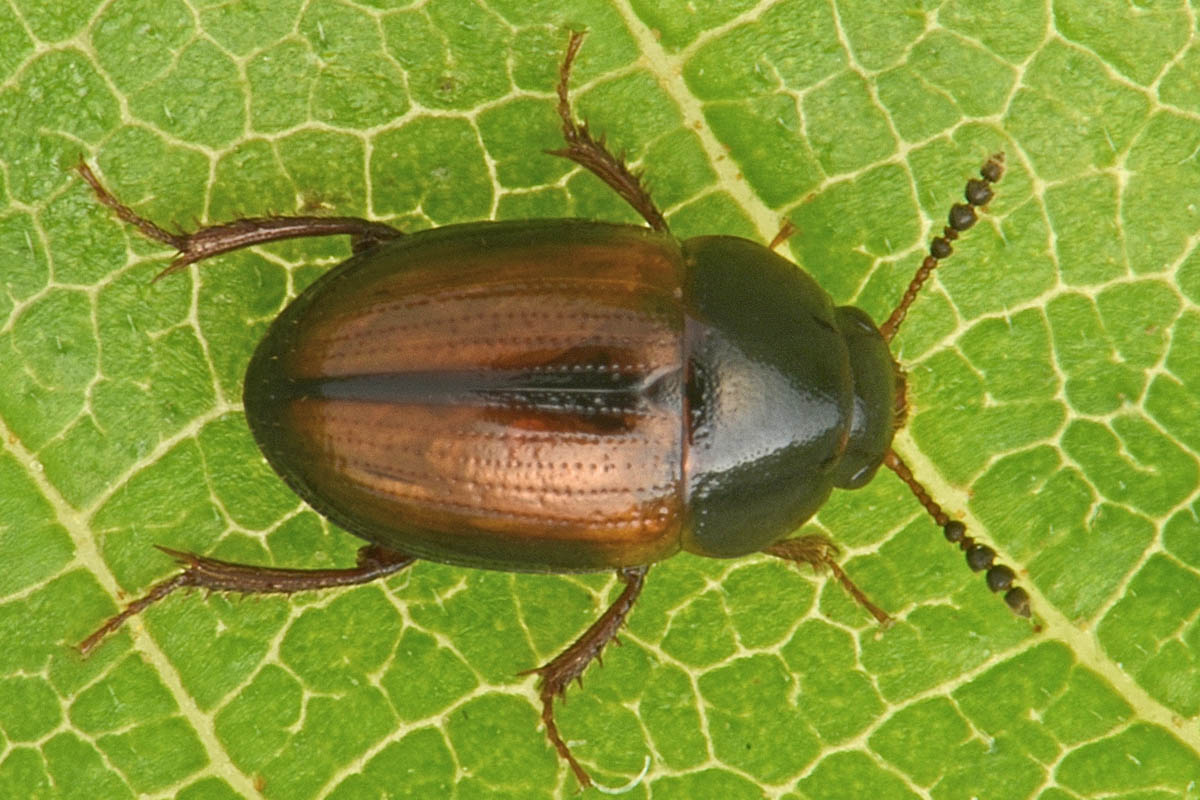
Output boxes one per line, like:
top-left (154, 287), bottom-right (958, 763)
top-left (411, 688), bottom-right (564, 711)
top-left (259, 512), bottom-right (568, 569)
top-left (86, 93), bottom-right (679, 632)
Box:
top-left (0, 0), bottom-right (1200, 800)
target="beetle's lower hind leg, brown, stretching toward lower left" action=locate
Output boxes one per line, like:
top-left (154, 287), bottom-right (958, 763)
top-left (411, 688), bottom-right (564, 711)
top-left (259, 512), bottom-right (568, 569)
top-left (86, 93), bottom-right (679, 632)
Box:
top-left (79, 545), bottom-right (416, 655)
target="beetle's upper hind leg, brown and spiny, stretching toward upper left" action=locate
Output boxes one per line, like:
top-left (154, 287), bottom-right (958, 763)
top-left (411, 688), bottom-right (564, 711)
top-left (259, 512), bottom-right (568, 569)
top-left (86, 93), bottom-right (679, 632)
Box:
top-left (76, 158), bottom-right (404, 281)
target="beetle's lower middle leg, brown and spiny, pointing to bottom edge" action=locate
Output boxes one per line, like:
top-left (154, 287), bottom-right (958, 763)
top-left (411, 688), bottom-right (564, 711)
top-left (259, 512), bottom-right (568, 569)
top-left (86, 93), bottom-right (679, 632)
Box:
top-left (521, 566), bottom-right (649, 788)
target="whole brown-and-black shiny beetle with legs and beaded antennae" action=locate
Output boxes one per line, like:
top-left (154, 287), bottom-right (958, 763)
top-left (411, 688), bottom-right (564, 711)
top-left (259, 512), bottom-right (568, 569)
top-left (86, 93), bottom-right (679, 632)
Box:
top-left (78, 34), bottom-right (1030, 786)
